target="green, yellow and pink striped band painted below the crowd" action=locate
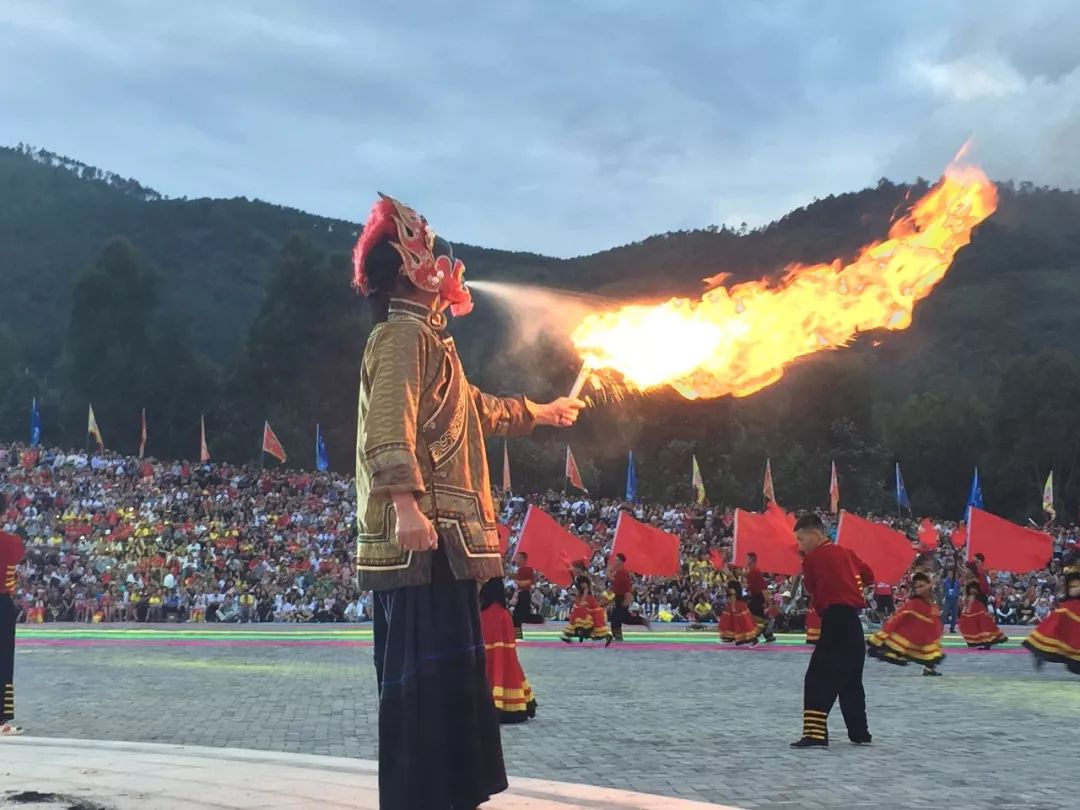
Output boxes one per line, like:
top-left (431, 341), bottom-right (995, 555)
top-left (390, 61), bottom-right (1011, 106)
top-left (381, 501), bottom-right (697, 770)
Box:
top-left (16, 624), bottom-right (1029, 654)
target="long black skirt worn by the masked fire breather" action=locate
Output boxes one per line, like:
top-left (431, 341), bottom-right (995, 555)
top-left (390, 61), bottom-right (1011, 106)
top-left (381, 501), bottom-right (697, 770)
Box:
top-left (375, 549), bottom-right (508, 810)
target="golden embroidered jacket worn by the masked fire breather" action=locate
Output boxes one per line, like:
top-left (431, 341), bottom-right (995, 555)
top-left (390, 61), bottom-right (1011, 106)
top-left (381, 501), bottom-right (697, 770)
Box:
top-left (356, 299), bottom-right (534, 591)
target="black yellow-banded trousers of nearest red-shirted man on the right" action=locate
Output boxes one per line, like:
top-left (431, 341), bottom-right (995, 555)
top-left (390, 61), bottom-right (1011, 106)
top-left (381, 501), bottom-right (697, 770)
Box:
top-left (802, 605), bottom-right (869, 741)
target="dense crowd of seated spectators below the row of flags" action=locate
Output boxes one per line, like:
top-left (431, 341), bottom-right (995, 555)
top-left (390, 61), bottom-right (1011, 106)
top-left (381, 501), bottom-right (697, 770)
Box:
top-left (0, 446), bottom-right (1080, 631)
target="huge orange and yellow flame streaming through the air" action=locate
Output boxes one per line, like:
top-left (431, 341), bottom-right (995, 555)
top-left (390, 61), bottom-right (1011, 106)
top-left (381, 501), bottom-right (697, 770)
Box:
top-left (572, 156), bottom-right (998, 400)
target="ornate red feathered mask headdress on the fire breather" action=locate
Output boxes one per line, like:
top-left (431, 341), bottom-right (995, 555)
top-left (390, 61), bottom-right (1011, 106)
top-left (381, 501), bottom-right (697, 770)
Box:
top-left (352, 193), bottom-right (472, 316)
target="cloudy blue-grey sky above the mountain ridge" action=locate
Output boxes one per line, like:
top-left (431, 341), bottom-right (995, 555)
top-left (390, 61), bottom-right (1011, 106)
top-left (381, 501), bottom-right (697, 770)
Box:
top-left (0, 0), bottom-right (1080, 256)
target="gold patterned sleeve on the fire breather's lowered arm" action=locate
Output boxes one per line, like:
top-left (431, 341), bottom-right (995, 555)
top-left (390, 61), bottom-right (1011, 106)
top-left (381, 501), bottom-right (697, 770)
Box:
top-left (356, 324), bottom-right (427, 499)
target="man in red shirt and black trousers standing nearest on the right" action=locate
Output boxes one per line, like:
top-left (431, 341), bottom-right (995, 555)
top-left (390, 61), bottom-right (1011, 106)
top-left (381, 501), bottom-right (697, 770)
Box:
top-left (792, 514), bottom-right (872, 748)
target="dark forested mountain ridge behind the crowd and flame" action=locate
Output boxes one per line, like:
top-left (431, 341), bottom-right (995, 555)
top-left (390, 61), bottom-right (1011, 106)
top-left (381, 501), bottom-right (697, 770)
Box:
top-left (0, 141), bottom-right (1080, 517)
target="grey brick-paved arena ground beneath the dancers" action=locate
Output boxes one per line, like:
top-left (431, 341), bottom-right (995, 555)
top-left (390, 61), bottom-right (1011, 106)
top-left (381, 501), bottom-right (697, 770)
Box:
top-left (6, 629), bottom-right (1080, 810)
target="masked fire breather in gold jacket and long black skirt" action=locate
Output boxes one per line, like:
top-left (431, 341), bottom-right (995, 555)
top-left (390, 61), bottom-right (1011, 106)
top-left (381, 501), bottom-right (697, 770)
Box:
top-left (353, 197), bottom-right (583, 810)
